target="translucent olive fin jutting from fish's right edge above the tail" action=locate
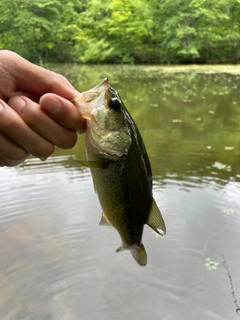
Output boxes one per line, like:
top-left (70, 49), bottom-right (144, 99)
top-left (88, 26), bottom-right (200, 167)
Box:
top-left (147, 199), bottom-right (166, 237)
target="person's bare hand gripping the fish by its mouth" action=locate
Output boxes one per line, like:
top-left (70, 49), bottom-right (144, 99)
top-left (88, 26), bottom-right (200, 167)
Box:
top-left (0, 50), bottom-right (85, 167)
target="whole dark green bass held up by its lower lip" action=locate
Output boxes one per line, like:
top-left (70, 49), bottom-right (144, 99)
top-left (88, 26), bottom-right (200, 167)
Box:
top-left (71, 78), bottom-right (166, 266)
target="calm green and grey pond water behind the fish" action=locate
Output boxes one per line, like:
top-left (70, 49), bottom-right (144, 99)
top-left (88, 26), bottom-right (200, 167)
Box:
top-left (0, 65), bottom-right (240, 320)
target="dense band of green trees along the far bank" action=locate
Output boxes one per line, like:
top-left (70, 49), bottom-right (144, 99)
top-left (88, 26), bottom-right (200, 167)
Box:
top-left (0, 0), bottom-right (240, 64)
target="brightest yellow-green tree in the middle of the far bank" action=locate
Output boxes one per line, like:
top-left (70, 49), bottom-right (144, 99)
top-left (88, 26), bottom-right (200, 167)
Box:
top-left (75, 0), bottom-right (151, 63)
